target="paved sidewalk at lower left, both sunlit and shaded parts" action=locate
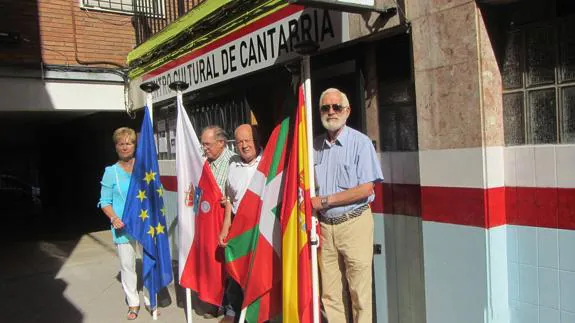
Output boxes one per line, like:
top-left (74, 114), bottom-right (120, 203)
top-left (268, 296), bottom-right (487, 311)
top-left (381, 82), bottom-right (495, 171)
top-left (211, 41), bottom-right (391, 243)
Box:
top-left (0, 230), bottom-right (218, 323)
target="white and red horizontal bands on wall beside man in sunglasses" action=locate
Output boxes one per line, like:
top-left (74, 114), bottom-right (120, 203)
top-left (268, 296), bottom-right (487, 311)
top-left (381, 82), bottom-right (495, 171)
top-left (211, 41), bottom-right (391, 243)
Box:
top-left (373, 145), bottom-right (575, 230)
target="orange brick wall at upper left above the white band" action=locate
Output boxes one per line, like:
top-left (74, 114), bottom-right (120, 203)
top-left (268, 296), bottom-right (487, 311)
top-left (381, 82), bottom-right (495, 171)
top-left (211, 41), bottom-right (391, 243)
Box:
top-left (0, 0), bottom-right (212, 66)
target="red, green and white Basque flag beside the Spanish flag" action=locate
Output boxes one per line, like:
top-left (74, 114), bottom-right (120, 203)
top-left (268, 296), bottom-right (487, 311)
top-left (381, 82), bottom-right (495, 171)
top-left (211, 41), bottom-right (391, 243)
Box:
top-left (226, 118), bottom-right (290, 323)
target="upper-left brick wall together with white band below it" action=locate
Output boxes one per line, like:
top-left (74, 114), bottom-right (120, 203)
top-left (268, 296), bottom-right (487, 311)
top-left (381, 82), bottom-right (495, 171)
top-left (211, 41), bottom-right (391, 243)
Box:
top-left (0, 0), bottom-right (141, 111)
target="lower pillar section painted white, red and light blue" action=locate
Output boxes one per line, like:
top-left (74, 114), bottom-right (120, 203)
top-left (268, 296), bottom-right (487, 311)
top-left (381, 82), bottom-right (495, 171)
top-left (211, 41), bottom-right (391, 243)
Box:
top-left (412, 147), bottom-right (509, 323)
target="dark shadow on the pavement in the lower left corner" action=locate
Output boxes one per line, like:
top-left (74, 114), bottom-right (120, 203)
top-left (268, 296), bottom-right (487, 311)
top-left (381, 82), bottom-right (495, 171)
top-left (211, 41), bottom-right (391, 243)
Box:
top-left (0, 230), bottom-right (83, 323)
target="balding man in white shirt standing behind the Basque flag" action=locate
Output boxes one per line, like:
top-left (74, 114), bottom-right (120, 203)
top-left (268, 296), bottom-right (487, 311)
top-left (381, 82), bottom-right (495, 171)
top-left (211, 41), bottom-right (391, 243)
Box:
top-left (219, 124), bottom-right (261, 323)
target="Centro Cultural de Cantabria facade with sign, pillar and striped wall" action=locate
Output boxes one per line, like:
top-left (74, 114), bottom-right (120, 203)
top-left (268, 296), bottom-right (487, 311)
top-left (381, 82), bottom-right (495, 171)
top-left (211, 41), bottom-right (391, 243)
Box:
top-left (128, 0), bottom-right (575, 323)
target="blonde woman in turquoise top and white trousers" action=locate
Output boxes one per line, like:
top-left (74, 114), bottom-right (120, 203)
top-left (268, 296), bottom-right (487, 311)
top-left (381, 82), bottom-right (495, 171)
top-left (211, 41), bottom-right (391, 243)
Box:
top-left (99, 127), bottom-right (150, 320)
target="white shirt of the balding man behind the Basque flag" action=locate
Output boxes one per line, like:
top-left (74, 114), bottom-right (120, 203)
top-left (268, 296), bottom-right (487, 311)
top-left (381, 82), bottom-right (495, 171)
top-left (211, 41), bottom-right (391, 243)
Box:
top-left (226, 153), bottom-right (262, 214)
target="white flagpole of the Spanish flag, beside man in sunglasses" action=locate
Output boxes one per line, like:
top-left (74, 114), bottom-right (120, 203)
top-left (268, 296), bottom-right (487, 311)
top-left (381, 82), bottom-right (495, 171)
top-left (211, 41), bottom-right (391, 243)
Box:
top-left (295, 39), bottom-right (320, 323)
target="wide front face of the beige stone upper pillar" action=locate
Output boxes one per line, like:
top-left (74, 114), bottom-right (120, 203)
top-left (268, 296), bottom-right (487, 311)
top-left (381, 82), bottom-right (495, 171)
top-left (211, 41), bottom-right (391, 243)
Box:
top-left (408, 1), bottom-right (488, 150)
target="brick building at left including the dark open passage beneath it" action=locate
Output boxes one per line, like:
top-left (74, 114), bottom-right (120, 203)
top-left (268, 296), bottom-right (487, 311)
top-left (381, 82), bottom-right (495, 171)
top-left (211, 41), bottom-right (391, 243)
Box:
top-left (0, 0), bottom-right (186, 230)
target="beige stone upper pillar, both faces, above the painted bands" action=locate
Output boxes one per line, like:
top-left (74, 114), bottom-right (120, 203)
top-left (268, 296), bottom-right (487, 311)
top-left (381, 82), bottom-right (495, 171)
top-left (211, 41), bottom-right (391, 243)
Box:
top-left (406, 1), bottom-right (503, 150)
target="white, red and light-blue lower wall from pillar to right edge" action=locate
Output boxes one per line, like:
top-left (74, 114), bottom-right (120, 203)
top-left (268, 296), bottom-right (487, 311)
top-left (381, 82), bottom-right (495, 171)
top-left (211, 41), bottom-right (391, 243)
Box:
top-left (410, 145), bottom-right (575, 323)
